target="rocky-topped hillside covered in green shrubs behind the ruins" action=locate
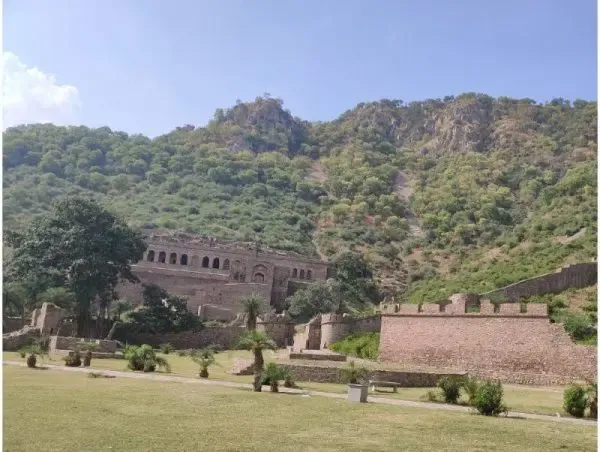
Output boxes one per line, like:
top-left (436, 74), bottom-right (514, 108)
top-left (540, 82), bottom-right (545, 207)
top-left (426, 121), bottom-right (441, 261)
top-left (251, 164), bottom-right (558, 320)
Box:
top-left (3, 94), bottom-right (597, 301)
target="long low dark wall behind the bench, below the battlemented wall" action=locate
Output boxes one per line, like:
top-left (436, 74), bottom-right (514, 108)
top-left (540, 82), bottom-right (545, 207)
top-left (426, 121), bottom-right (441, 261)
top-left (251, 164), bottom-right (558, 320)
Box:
top-left (278, 364), bottom-right (465, 388)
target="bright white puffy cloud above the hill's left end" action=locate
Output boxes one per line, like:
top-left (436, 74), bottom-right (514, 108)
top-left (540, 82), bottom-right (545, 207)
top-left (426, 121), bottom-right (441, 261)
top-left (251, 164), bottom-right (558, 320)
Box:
top-left (2, 52), bottom-right (81, 129)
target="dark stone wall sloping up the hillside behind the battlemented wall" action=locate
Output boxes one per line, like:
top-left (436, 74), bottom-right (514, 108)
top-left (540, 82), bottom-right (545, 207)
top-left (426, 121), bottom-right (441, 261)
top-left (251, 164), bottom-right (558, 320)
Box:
top-left (482, 262), bottom-right (598, 301)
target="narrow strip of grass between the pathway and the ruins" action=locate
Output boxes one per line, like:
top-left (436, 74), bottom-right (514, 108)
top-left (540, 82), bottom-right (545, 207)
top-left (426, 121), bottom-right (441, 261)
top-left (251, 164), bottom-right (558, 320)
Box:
top-left (3, 350), bottom-right (566, 416)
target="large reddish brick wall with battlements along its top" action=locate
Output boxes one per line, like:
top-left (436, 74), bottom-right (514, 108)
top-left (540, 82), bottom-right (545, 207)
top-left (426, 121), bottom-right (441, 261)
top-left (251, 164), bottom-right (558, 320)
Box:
top-left (379, 302), bottom-right (597, 380)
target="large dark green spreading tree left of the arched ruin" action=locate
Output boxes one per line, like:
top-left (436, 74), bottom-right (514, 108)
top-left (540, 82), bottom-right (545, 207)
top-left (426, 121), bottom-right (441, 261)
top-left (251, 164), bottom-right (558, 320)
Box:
top-left (8, 197), bottom-right (146, 337)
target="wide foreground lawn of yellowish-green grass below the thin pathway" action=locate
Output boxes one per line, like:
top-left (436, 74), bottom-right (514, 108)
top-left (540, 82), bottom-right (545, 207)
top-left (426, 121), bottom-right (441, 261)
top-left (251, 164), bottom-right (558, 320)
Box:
top-left (3, 368), bottom-right (596, 452)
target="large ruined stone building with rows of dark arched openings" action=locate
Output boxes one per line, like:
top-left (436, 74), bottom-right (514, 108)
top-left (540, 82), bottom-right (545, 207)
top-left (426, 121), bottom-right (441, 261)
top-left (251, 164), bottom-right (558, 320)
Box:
top-left (117, 231), bottom-right (329, 320)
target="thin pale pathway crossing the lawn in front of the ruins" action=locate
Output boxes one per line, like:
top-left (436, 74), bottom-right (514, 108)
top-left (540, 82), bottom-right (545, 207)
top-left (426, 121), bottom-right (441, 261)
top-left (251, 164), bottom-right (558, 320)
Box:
top-left (3, 361), bottom-right (597, 426)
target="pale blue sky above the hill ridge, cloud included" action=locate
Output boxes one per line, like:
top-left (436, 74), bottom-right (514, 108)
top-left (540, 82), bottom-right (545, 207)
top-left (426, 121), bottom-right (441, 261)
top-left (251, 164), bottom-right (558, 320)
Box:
top-left (2, 0), bottom-right (598, 137)
